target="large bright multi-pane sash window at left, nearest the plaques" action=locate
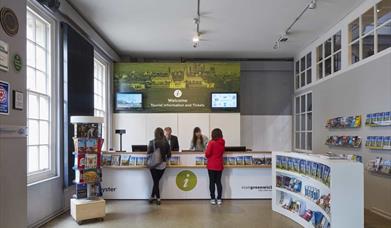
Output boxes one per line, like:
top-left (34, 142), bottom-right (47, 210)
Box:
top-left (26, 8), bottom-right (56, 183)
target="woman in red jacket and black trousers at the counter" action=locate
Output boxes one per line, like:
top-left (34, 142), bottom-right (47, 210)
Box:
top-left (205, 128), bottom-right (225, 205)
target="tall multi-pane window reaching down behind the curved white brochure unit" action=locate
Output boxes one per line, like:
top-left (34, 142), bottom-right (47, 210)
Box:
top-left (294, 92), bottom-right (312, 151)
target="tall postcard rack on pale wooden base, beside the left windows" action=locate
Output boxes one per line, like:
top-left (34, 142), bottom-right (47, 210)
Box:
top-left (71, 116), bottom-right (106, 223)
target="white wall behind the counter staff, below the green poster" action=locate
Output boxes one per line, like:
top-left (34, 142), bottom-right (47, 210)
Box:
top-left (111, 113), bottom-right (240, 151)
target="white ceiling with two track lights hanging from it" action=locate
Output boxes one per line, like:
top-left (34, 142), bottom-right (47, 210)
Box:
top-left (68, 0), bottom-right (364, 58)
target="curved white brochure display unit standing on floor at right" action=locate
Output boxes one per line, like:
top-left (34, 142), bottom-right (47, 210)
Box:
top-left (272, 152), bottom-right (364, 228)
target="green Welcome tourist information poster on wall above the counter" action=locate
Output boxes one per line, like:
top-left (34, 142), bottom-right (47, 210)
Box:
top-left (114, 62), bottom-right (240, 113)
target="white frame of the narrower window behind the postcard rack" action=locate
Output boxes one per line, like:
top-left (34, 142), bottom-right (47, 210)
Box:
top-left (94, 52), bottom-right (110, 150)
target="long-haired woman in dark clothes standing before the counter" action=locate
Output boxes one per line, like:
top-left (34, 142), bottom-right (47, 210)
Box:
top-left (148, 127), bottom-right (171, 205)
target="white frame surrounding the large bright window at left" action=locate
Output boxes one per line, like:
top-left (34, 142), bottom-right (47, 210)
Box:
top-left (26, 2), bottom-right (58, 185)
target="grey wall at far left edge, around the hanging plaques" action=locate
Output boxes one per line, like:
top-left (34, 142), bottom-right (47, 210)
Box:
top-left (0, 0), bottom-right (27, 228)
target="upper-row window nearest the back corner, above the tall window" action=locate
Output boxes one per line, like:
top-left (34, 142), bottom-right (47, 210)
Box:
top-left (295, 52), bottom-right (312, 89)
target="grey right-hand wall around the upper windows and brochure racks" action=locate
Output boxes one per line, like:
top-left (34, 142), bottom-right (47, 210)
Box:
top-left (292, 0), bottom-right (391, 217)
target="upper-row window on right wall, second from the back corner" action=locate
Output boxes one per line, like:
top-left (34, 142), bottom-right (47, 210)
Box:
top-left (316, 31), bottom-right (341, 80)
